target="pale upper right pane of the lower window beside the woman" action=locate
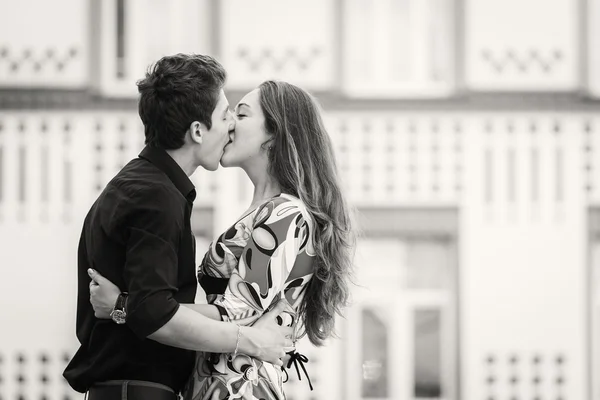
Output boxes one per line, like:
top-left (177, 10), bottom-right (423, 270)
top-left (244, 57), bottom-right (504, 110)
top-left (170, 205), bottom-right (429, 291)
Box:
top-left (406, 240), bottom-right (450, 289)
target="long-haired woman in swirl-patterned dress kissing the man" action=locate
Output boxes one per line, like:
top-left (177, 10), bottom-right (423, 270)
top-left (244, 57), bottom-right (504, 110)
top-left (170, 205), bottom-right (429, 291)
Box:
top-left (86, 81), bottom-right (354, 400)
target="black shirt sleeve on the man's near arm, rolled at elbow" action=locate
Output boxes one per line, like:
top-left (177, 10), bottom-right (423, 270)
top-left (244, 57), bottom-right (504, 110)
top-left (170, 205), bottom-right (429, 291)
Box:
top-left (118, 190), bottom-right (183, 338)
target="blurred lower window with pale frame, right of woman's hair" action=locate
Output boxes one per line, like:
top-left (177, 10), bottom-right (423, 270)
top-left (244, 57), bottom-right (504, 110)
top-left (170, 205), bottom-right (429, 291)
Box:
top-left (346, 234), bottom-right (457, 400)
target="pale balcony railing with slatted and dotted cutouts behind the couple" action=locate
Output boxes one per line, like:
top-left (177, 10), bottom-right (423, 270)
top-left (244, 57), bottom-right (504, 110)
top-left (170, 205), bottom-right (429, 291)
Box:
top-left (0, 111), bottom-right (600, 223)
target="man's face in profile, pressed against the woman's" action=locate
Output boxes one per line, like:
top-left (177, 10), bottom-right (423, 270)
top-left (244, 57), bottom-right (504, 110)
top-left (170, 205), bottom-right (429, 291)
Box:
top-left (198, 89), bottom-right (235, 171)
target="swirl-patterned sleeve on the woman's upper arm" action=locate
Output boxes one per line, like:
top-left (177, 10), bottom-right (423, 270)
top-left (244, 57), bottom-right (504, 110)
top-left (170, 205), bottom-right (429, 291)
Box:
top-left (214, 198), bottom-right (311, 325)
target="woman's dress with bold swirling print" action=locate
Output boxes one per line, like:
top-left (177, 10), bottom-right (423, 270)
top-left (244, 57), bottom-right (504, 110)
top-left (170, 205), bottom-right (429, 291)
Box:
top-left (184, 194), bottom-right (315, 400)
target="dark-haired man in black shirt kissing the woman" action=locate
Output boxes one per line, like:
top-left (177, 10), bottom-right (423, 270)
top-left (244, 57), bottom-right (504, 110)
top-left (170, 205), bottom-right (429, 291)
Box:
top-left (64, 54), bottom-right (291, 400)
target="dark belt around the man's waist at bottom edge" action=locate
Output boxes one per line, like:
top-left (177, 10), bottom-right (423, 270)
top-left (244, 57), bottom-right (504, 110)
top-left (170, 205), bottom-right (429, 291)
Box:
top-left (87, 381), bottom-right (177, 400)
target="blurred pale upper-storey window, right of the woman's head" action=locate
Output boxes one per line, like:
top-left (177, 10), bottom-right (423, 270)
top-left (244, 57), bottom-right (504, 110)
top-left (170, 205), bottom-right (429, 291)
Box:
top-left (342, 0), bottom-right (455, 97)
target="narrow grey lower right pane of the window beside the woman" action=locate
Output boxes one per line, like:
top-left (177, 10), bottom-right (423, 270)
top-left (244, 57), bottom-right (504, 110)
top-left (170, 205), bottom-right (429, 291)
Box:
top-left (414, 309), bottom-right (442, 398)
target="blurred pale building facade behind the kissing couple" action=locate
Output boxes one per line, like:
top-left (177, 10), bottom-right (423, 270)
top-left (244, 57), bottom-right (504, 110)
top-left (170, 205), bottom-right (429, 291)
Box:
top-left (0, 0), bottom-right (600, 400)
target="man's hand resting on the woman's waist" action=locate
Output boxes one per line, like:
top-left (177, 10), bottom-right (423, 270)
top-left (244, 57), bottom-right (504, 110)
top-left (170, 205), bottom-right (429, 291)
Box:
top-left (240, 301), bottom-right (293, 366)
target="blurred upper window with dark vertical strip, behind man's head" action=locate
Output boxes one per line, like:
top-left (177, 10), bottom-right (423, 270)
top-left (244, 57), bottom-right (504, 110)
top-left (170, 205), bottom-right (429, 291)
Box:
top-left (90, 0), bottom-right (217, 98)
